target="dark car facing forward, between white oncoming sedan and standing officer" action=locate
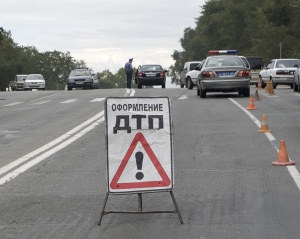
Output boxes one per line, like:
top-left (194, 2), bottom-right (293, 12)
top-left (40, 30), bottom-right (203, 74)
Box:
top-left (67, 68), bottom-right (98, 90)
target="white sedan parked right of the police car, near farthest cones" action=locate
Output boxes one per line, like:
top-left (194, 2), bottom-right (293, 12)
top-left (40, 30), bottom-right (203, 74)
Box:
top-left (259, 59), bottom-right (300, 89)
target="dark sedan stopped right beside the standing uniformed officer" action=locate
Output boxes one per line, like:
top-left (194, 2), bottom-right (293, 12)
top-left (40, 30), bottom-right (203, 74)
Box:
top-left (135, 64), bottom-right (168, 89)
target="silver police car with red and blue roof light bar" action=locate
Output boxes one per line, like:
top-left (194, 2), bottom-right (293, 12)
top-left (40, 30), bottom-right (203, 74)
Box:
top-left (197, 50), bottom-right (250, 98)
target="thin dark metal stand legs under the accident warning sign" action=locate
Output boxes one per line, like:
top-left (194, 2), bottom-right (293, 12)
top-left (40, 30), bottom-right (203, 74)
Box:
top-left (98, 190), bottom-right (183, 225)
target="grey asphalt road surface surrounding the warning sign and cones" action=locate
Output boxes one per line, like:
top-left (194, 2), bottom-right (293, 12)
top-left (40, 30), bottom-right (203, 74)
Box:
top-left (0, 87), bottom-right (300, 239)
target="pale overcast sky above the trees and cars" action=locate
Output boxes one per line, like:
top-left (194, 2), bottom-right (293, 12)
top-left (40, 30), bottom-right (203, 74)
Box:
top-left (0, 0), bottom-right (206, 76)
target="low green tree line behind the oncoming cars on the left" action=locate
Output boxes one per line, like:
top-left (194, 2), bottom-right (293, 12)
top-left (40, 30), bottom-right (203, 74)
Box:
top-left (0, 27), bottom-right (135, 91)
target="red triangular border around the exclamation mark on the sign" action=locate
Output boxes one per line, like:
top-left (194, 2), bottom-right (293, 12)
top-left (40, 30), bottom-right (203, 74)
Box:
top-left (110, 133), bottom-right (171, 189)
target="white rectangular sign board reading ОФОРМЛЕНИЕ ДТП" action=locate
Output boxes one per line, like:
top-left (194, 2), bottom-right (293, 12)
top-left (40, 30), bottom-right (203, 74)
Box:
top-left (105, 97), bottom-right (174, 193)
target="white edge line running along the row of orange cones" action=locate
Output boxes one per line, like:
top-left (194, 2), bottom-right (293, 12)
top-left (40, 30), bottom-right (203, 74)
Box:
top-left (229, 98), bottom-right (300, 190)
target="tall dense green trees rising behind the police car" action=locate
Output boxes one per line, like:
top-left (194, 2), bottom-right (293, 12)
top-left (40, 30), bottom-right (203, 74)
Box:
top-left (169, 0), bottom-right (300, 84)
